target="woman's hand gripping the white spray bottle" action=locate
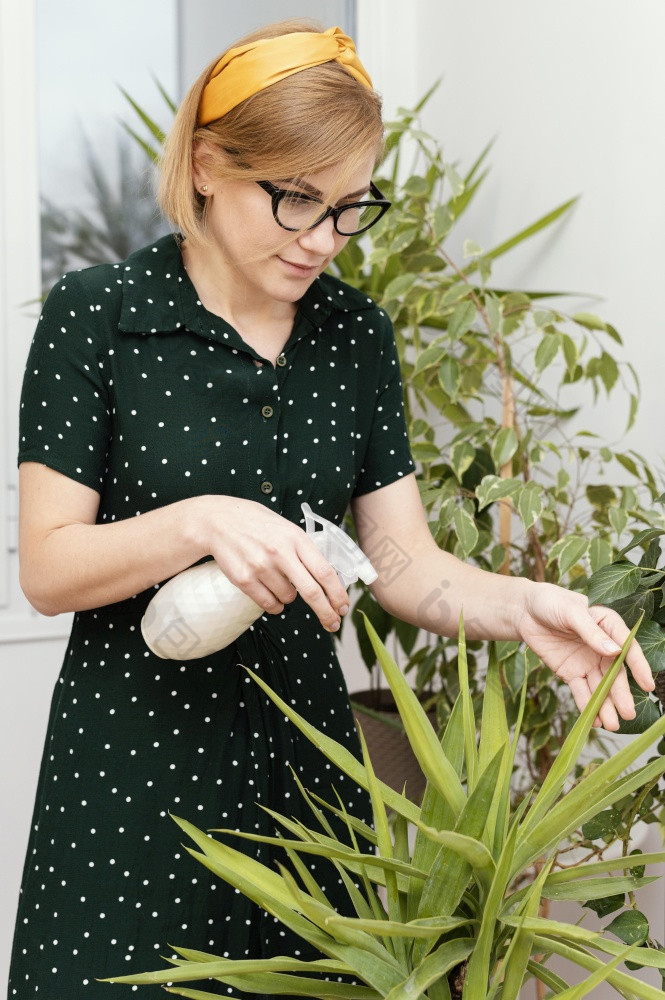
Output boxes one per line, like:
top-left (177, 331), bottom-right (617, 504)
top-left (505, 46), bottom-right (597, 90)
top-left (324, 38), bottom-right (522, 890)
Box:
top-left (195, 495), bottom-right (349, 632)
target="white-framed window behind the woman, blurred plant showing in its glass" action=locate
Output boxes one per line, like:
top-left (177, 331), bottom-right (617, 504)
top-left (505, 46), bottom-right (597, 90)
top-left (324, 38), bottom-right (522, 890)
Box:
top-left (0, 0), bottom-right (355, 643)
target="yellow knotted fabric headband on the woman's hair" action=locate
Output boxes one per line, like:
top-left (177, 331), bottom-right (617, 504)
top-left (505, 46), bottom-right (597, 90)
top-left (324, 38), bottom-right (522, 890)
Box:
top-left (198, 28), bottom-right (372, 125)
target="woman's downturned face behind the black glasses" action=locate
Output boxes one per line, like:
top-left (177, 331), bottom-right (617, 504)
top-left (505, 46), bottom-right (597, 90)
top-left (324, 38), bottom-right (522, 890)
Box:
top-left (194, 157), bottom-right (374, 306)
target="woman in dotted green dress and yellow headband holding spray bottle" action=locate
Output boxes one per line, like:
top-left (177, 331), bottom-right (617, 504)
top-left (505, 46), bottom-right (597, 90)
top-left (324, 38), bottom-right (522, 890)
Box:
top-left (10, 22), bottom-right (653, 998)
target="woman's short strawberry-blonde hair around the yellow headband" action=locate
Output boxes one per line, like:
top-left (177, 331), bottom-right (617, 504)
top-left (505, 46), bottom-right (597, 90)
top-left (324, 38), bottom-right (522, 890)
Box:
top-left (157, 20), bottom-right (383, 244)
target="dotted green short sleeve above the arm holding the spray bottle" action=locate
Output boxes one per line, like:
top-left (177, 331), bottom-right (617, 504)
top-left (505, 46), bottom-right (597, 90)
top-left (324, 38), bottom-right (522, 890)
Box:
top-left (18, 271), bottom-right (111, 492)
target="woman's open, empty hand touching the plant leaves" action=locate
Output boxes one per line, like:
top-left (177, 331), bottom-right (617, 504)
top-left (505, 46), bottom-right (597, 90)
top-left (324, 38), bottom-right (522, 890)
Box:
top-left (518, 583), bottom-right (654, 730)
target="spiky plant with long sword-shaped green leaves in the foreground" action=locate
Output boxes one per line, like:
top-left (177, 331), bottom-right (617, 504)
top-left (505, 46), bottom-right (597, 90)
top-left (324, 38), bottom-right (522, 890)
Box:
top-left (105, 622), bottom-right (665, 1000)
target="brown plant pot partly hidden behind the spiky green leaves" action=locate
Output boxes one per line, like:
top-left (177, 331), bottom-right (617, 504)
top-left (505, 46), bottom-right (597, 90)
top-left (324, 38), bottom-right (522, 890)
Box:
top-left (351, 688), bottom-right (436, 804)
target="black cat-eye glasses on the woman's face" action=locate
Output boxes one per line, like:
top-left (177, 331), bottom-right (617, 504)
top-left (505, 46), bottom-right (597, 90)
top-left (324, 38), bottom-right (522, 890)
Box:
top-left (256, 181), bottom-right (390, 236)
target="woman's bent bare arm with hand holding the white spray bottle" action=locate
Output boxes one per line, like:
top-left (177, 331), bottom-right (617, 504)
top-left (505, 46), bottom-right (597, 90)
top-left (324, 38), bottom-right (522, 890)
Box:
top-left (19, 462), bottom-right (348, 631)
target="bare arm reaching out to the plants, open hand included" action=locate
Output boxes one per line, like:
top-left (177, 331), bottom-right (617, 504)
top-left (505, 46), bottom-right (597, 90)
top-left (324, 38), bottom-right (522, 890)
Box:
top-left (352, 476), bottom-right (653, 729)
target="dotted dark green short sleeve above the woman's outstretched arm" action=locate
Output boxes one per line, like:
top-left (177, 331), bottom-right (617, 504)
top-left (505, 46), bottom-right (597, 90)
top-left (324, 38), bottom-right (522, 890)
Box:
top-left (353, 310), bottom-right (415, 497)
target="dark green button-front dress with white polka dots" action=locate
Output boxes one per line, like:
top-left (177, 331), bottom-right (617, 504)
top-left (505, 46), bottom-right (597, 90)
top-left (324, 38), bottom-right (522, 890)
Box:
top-left (9, 237), bottom-right (413, 1000)
